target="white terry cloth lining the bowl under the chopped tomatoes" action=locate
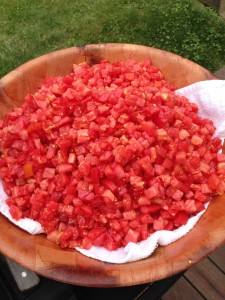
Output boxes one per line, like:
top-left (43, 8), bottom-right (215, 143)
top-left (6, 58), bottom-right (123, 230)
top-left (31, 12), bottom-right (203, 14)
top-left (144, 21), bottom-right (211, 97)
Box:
top-left (0, 80), bottom-right (225, 264)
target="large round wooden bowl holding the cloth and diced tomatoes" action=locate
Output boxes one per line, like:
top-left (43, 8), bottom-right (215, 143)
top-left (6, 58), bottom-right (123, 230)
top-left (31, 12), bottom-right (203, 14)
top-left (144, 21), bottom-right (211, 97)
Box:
top-left (0, 44), bottom-right (225, 287)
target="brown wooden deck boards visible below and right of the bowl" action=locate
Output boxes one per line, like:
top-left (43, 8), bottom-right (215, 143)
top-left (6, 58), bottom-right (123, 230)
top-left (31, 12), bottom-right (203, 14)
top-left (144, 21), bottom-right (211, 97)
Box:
top-left (161, 67), bottom-right (225, 300)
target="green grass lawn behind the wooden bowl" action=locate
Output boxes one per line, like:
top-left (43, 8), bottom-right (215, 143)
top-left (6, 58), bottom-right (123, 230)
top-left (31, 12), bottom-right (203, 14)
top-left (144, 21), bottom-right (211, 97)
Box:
top-left (0, 0), bottom-right (225, 77)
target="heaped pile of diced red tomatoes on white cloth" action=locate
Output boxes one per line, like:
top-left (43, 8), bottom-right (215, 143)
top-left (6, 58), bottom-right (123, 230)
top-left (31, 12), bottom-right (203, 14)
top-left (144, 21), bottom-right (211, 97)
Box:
top-left (0, 60), bottom-right (225, 251)
